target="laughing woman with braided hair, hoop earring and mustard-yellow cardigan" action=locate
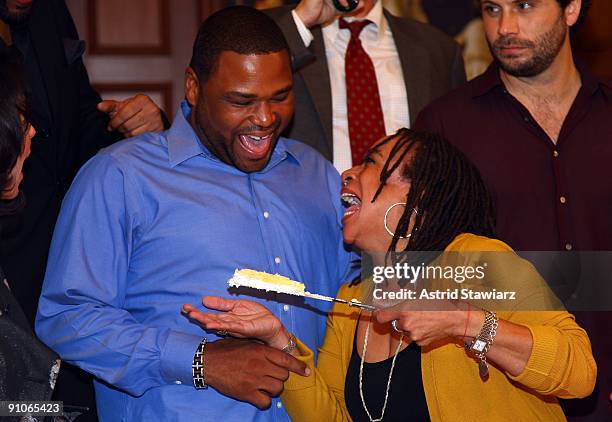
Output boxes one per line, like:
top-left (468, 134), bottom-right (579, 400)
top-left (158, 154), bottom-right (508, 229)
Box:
top-left (183, 129), bottom-right (596, 421)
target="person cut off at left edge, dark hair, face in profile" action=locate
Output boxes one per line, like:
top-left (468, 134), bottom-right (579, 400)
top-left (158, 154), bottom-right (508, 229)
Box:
top-left (0, 43), bottom-right (60, 416)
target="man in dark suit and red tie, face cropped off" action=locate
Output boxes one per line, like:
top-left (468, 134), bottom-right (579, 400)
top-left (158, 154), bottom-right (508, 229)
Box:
top-left (268, 0), bottom-right (465, 171)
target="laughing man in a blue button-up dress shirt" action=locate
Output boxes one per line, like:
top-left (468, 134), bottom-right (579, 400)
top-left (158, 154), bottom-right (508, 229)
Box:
top-left (36, 7), bottom-right (352, 421)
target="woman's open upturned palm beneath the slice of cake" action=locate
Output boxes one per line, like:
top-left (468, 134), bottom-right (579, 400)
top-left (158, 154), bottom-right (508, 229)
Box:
top-left (182, 296), bottom-right (290, 350)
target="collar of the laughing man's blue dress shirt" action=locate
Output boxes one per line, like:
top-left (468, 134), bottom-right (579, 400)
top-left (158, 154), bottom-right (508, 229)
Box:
top-left (166, 100), bottom-right (300, 173)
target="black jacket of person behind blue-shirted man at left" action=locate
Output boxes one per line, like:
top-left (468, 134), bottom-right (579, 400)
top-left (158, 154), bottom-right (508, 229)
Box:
top-left (1, 0), bottom-right (121, 322)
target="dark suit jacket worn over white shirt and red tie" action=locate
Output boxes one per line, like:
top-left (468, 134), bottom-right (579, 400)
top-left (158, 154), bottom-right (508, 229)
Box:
top-left (267, 6), bottom-right (465, 161)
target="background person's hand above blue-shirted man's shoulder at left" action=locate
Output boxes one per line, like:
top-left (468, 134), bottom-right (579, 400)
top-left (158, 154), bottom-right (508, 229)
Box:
top-left (98, 94), bottom-right (164, 138)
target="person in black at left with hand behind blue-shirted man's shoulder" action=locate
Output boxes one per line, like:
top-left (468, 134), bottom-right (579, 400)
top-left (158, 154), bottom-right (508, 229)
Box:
top-left (0, 0), bottom-right (169, 421)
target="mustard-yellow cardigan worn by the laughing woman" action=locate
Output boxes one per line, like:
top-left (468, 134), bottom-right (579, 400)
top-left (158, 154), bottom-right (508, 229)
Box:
top-left (281, 234), bottom-right (597, 422)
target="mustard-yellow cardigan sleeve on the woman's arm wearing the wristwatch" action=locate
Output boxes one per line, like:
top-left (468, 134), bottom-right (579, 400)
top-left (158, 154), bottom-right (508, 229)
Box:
top-left (452, 235), bottom-right (597, 398)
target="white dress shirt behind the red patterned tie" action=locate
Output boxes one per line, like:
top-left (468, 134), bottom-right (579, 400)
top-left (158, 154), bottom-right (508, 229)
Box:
top-left (292, 1), bottom-right (410, 172)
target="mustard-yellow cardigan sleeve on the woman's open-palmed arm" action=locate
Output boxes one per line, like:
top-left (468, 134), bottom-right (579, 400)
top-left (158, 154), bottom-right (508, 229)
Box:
top-left (281, 286), bottom-right (356, 422)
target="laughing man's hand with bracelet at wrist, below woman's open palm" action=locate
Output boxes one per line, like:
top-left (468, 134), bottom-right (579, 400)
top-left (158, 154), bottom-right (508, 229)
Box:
top-left (204, 339), bottom-right (310, 409)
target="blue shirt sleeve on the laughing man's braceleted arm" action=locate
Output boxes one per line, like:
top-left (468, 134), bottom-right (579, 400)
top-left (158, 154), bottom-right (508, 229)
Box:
top-left (36, 152), bottom-right (202, 396)
